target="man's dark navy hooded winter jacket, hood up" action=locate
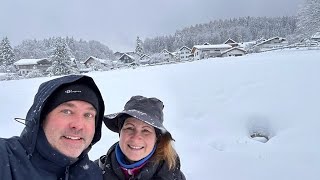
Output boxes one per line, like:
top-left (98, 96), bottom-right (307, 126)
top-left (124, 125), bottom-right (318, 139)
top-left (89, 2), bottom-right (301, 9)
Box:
top-left (0, 75), bottom-right (104, 180)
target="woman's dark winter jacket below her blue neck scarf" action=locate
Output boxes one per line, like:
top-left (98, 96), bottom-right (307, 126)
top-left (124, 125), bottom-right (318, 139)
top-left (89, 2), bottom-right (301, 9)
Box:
top-left (95, 143), bottom-right (186, 180)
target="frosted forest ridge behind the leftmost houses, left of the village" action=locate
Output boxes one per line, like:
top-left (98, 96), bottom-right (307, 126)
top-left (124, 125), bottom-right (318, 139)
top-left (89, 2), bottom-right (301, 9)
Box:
top-left (13, 37), bottom-right (115, 62)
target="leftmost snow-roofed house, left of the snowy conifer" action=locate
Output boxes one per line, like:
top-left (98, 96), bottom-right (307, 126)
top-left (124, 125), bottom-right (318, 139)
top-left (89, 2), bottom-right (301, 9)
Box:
top-left (13, 58), bottom-right (52, 75)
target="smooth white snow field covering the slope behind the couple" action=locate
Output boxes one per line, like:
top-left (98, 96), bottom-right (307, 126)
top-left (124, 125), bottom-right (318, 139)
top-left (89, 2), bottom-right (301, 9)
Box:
top-left (0, 49), bottom-right (320, 180)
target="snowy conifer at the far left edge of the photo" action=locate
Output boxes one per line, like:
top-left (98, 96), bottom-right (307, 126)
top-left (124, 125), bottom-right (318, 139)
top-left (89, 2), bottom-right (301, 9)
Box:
top-left (0, 37), bottom-right (15, 69)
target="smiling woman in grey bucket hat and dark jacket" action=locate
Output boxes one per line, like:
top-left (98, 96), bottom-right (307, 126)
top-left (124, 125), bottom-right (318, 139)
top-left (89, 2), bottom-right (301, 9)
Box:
top-left (96, 96), bottom-right (185, 180)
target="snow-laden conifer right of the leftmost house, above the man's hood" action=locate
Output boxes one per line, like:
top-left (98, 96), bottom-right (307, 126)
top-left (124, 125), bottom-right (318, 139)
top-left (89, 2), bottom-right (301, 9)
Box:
top-left (47, 39), bottom-right (79, 76)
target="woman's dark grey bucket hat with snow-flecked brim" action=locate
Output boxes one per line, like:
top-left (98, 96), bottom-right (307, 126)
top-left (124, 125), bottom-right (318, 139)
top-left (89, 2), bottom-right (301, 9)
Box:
top-left (103, 95), bottom-right (172, 139)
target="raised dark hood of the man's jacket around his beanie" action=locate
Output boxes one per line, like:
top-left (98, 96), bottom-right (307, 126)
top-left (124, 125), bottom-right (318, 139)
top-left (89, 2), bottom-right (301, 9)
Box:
top-left (20, 75), bottom-right (105, 154)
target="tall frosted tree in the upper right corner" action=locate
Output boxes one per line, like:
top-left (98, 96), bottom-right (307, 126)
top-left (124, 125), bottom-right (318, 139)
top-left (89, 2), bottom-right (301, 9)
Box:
top-left (296, 0), bottom-right (320, 40)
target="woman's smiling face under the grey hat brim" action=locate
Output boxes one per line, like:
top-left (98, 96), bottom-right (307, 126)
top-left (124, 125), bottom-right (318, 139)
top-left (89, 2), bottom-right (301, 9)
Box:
top-left (119, 117), bottom-right (156, 161)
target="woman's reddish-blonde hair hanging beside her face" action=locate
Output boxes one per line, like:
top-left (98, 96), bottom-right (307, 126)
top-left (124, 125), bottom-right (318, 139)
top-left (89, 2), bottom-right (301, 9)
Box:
top-left (152, 133), bottom-right (178, 170)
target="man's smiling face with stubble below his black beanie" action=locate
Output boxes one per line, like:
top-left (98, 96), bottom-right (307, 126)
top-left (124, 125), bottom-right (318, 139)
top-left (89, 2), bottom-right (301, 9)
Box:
top-left (42, 100), bottom-right (97, 158)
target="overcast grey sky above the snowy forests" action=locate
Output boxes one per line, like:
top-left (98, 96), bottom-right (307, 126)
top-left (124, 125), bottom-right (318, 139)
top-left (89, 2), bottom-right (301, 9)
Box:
top-left (0, 0), bottom-right (304, 51)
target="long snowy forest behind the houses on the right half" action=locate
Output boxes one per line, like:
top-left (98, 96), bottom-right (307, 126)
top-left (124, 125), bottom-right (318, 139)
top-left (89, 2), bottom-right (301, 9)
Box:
top-left (143, 16), bottom-right (297, 54)
